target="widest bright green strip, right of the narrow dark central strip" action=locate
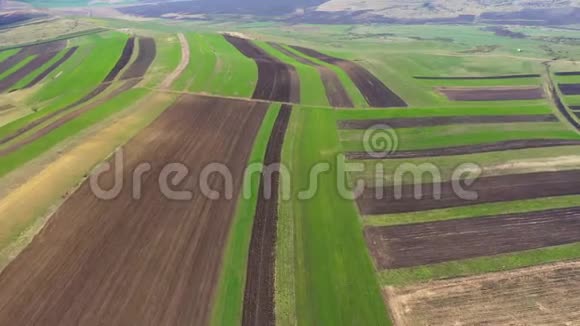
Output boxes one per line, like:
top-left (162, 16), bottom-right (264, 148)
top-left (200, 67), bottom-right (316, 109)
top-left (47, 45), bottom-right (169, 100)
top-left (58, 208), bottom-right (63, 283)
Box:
top-left (275, 108), bottom-right (391, 325)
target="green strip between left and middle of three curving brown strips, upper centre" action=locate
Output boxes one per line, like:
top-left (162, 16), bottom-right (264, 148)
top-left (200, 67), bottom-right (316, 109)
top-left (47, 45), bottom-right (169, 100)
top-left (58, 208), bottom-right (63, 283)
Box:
top-left (254, 41), bottom-right (330, 106)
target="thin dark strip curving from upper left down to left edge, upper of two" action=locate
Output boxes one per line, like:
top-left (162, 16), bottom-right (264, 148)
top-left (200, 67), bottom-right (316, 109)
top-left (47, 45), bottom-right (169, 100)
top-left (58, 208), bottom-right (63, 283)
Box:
top-left (0, 39), bottom-right (133, 145)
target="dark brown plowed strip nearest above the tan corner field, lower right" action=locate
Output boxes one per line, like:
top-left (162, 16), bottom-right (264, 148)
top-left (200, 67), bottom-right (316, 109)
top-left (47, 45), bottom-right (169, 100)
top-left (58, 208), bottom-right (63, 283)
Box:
top-left (365, 207), bottom-right (580, 269)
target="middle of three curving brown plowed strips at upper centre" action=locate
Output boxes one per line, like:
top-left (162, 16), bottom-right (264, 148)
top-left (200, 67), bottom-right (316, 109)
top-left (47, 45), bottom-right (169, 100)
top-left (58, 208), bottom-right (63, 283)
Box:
top-left (269, 42), bottom-right (354, 108)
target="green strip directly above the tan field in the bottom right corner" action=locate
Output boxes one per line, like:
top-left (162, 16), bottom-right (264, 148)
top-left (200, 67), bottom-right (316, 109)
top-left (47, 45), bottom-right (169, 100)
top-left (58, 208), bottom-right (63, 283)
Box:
top-left (379, 239), bottom-right (580, 286)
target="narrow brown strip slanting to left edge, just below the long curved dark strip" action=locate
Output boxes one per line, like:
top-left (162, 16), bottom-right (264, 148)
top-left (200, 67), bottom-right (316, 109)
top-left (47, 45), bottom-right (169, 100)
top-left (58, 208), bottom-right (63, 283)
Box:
top-left (0, 79), bottom-right (141, 156)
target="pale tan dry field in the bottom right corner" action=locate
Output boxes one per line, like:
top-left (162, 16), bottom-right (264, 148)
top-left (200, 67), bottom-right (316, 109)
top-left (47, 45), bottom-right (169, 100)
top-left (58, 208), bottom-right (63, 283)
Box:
top-left (385, 262), bottom-right (580, 326)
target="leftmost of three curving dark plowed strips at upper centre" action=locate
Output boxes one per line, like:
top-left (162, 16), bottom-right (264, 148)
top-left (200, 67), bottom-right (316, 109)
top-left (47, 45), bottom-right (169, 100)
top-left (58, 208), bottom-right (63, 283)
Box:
top-left (224, 35), bottom-right (300, 103)
